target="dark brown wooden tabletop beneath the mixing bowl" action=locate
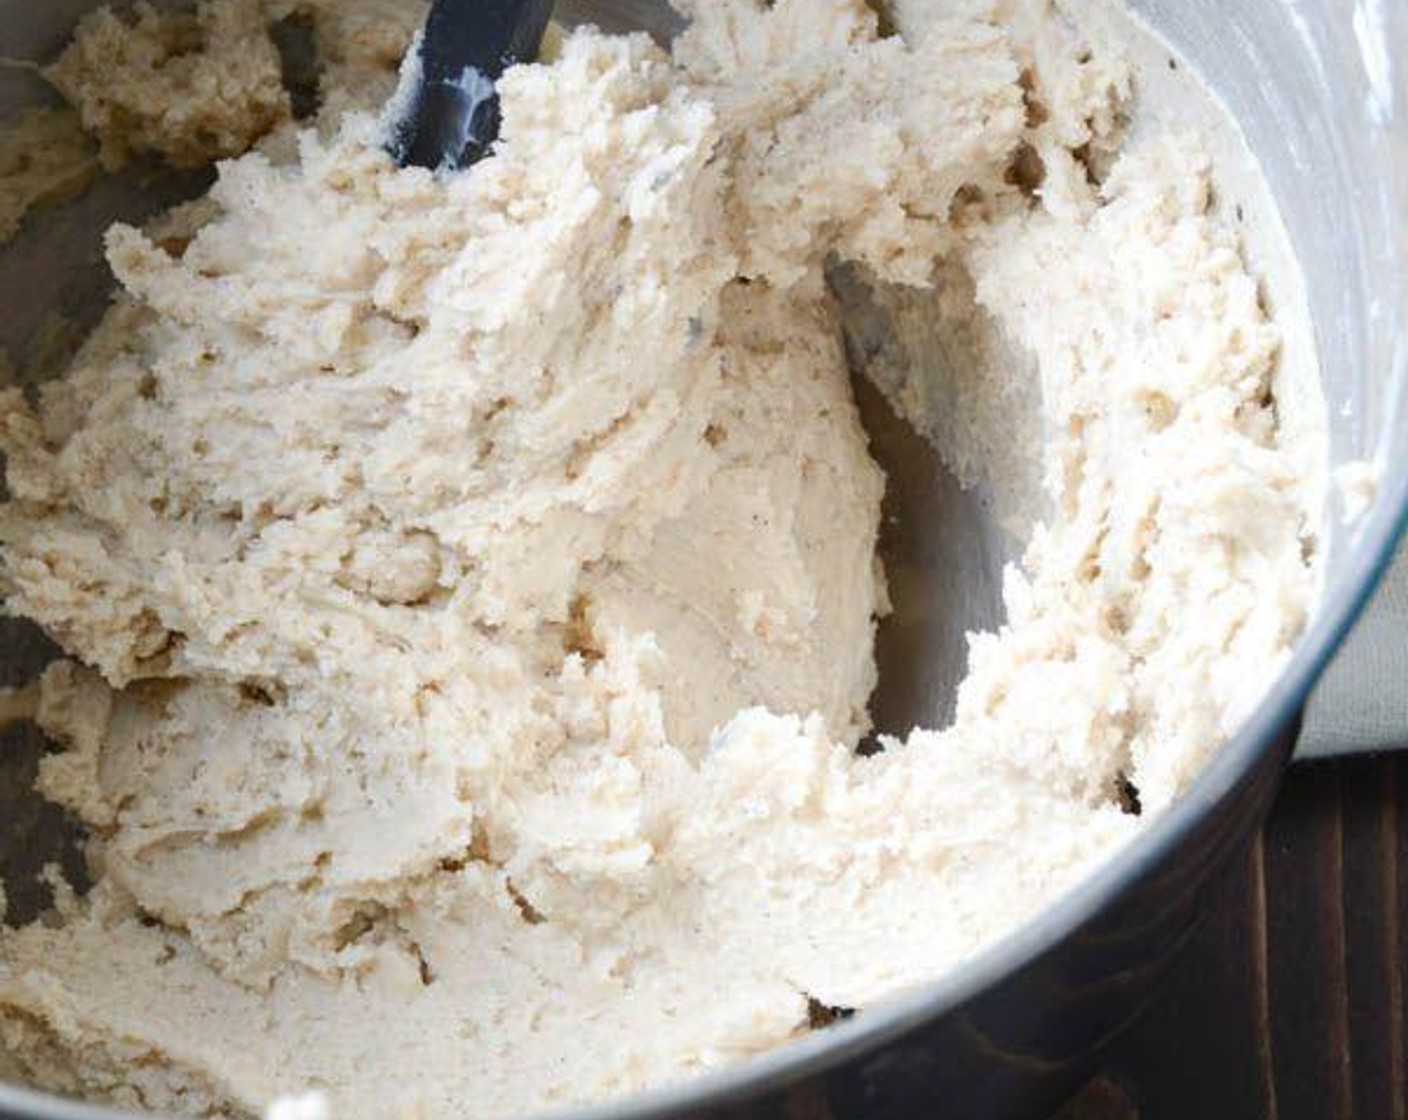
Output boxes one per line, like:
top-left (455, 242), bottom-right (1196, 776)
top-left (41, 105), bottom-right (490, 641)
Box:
top-left (1059, 752), bottom-right (1408, 1120)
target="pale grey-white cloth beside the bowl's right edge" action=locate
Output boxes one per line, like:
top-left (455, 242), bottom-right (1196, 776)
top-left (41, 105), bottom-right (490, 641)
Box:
top-left (1297, 538), bottom-right (1408, 758)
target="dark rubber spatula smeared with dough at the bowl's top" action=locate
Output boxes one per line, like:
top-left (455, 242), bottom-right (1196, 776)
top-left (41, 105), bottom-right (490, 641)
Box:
top-left (387, 0), bottom-right (552, 170)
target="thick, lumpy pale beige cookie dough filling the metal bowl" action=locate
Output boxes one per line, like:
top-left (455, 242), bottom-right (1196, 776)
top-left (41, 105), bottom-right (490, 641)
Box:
top-left (0, 0), bottom-right (1319, 1120)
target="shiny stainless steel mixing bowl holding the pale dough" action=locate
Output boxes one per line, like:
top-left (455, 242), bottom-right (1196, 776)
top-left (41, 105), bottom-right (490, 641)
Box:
top-left (0, 0), bottom-right (1408, 1120)
